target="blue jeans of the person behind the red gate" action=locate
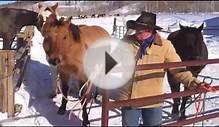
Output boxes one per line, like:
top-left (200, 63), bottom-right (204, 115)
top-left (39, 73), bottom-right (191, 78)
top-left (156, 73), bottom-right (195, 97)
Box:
top-left (122, 107), bottom-right (162, 126)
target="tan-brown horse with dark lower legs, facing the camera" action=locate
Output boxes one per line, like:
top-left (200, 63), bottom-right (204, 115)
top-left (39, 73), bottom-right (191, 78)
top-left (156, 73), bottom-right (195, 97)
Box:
top-left (42, 14), bottom-right (110, 126)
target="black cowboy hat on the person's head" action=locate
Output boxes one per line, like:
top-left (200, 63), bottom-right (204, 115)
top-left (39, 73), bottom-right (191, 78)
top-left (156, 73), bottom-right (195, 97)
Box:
top-left (126, 11), bottom-right (163, 30)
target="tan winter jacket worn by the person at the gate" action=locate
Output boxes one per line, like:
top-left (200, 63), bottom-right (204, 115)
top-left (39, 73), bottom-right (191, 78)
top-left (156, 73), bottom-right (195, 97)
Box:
top-left (118, 33), bottom-right (196, 108)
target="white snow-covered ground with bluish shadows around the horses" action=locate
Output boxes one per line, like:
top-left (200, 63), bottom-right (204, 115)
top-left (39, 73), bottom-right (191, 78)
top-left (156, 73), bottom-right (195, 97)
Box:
top-left (0, 13), bottom-right (219, 126)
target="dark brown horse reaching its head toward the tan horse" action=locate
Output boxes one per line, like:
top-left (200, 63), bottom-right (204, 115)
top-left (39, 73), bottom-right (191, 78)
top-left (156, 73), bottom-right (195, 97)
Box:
top-left (0, 8), bottom-right (43, 49)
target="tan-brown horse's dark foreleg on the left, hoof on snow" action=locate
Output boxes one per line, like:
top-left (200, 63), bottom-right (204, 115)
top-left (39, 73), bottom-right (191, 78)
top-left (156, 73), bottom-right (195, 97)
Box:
top-left (57, 80), bottom-right (69, 115)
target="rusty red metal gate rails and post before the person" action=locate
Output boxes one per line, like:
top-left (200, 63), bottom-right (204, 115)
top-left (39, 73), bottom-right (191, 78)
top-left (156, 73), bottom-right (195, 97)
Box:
top-left (101, 59), bottom-right (219, 126)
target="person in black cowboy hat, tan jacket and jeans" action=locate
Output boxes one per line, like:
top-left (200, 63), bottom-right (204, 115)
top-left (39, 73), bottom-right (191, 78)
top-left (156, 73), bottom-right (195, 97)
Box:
top-left (117, 11), bottom-right (204, 126)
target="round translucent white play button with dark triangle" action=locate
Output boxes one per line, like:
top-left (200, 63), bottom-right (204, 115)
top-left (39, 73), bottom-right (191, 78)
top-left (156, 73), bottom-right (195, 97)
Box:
top-left (83, 38), bottom-right (135, 89)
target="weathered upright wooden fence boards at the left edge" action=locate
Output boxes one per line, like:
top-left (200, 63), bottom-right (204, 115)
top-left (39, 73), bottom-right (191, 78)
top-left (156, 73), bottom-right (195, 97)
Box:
top-left (0, 50), bottom-right (15, 117)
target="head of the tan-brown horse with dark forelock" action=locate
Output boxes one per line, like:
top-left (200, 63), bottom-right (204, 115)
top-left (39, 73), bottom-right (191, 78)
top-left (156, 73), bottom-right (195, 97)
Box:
top-left (42, 15), bottom-right (81, 65)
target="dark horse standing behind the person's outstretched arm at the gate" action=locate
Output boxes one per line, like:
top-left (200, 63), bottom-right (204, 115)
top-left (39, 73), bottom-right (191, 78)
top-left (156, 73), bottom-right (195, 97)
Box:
top-left (167, 24), bottom-right (208, 119)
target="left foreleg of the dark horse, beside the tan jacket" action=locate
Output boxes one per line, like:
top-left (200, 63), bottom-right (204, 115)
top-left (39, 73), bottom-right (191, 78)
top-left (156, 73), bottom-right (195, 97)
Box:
top-left (167, 72), bottom-right (180, 116)
